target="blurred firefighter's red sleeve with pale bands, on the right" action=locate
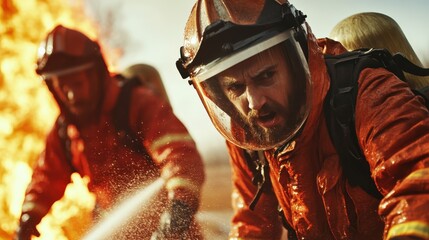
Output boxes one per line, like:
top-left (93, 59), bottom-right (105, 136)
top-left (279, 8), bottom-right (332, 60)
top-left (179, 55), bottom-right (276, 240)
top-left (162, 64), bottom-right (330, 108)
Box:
top-left (131, 88), bottom-right (205, 211)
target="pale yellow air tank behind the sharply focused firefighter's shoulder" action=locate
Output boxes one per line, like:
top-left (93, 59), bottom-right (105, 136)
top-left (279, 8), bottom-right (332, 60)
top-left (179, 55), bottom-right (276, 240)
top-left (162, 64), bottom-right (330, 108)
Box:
top-left (329, 12), bottom-right (429, 89)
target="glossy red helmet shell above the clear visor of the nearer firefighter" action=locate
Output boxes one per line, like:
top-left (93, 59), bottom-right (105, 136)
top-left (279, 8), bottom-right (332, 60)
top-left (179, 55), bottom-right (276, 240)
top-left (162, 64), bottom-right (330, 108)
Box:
top-left (177, 0), bottom-right (307, 78)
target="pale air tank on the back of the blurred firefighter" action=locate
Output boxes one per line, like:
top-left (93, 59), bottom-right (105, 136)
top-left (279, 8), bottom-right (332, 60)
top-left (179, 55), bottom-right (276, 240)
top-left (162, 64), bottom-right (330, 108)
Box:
top-left (121, 63), bottom-right (170, 103)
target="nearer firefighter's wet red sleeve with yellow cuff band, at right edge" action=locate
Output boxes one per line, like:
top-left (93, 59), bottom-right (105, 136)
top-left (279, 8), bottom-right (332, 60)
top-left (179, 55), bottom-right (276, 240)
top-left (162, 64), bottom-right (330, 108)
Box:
top-left (356, 69), bottom-right (429, 239)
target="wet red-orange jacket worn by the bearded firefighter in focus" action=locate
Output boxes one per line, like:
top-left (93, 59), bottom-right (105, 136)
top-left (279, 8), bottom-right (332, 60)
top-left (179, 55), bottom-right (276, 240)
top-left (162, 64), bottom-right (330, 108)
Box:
top-left (228, 24), bottom-right (429, 240)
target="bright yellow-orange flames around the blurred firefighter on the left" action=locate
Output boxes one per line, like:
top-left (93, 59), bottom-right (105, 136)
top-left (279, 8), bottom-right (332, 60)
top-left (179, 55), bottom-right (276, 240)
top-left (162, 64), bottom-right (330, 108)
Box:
top-left (0, 0), bottom-right (119, 239)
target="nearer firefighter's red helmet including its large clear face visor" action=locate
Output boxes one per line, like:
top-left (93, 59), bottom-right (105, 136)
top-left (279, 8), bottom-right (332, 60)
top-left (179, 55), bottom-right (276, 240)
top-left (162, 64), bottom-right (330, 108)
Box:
top-left (176, 0), bottom-right (311, 150)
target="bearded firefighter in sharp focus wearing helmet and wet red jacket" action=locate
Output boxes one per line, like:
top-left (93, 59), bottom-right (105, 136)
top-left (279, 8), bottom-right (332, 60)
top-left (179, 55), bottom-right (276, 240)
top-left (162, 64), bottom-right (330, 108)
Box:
top-left (177, 0), bottom-right (429, 240)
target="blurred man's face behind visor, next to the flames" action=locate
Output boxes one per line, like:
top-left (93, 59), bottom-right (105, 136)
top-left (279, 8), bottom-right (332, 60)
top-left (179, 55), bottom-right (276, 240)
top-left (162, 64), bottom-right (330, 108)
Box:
top-left (52, 67), bottom-right (100, 121)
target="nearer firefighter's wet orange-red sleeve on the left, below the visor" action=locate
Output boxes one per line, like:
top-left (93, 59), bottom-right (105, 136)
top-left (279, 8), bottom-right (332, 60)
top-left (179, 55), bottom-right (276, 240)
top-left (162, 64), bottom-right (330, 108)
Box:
top-left (227, 142), bottom-right (282, 240)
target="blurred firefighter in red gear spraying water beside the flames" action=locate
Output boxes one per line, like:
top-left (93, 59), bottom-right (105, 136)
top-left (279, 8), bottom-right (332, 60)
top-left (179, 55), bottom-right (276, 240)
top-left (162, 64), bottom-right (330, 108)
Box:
top-left (16, 25), bottom-right (205, 240)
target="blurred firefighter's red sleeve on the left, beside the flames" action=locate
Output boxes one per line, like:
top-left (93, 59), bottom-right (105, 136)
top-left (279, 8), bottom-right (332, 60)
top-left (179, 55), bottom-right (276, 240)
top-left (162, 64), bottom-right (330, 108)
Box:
top-left (22, 122), bottom-right (72, 219)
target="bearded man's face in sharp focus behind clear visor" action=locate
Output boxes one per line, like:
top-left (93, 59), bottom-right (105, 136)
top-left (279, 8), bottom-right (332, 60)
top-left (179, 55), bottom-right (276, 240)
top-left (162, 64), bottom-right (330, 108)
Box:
top-left (218, 47), bottom-right (293, 142)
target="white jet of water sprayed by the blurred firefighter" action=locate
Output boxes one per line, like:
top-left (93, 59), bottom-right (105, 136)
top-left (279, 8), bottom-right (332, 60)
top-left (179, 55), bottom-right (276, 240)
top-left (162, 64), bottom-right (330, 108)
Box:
top-left (82, 178), bottom-right (165, 240)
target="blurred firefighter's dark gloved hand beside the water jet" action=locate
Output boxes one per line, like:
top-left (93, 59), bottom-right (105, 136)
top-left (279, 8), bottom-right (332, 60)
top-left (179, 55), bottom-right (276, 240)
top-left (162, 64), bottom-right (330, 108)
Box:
top-left (151, 199), bottom-right (193, 240)
